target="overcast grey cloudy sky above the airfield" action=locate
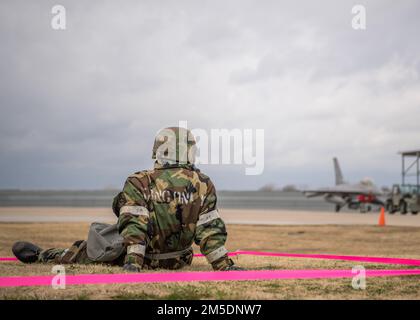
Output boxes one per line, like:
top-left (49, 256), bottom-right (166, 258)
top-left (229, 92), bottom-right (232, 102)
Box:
top-left (0, 0), bottom-right (420, 189)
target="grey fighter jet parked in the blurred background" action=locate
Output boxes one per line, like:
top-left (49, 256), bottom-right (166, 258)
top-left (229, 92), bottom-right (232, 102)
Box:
top-left (302, 158), bottom-right (384, 212)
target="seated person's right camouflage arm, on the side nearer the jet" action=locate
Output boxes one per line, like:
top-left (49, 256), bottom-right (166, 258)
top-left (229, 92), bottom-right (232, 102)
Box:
top-left (194, 181), bottom-right (233, 270)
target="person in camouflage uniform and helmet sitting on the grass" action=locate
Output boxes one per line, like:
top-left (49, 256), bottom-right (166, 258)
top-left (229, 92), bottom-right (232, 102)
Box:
top-left (14, 127), bottom-right (240, 271)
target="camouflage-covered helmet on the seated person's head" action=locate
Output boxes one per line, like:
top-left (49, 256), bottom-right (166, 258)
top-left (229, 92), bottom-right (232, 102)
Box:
top-left (152, 127), bottom-right (196, 164)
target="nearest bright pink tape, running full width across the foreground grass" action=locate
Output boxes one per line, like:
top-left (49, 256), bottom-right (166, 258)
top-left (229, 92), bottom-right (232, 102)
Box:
top-left (0, 269), bottom-right (420, 287)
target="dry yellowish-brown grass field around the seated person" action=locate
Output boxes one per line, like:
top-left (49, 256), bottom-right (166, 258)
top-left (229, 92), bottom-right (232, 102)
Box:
top-left (0, 223), bottom-right (420, 299)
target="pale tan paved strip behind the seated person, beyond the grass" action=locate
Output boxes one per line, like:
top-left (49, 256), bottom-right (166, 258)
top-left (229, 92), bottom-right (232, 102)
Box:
top-left (0, 207), bottom-right (420, 227)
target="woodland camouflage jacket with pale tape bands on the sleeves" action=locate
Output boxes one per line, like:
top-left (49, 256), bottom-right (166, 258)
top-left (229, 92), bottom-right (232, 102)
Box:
top-left (113, 162), bottom-right (233, 270)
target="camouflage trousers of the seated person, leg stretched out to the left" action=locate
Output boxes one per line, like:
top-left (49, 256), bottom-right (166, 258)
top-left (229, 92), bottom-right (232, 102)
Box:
top-left (38, 240), bottom-right (193, 270)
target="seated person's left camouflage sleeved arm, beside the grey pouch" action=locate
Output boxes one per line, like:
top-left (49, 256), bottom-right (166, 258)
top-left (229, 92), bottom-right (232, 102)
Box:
top-left (114, 176), bottom-right (150, 271)
